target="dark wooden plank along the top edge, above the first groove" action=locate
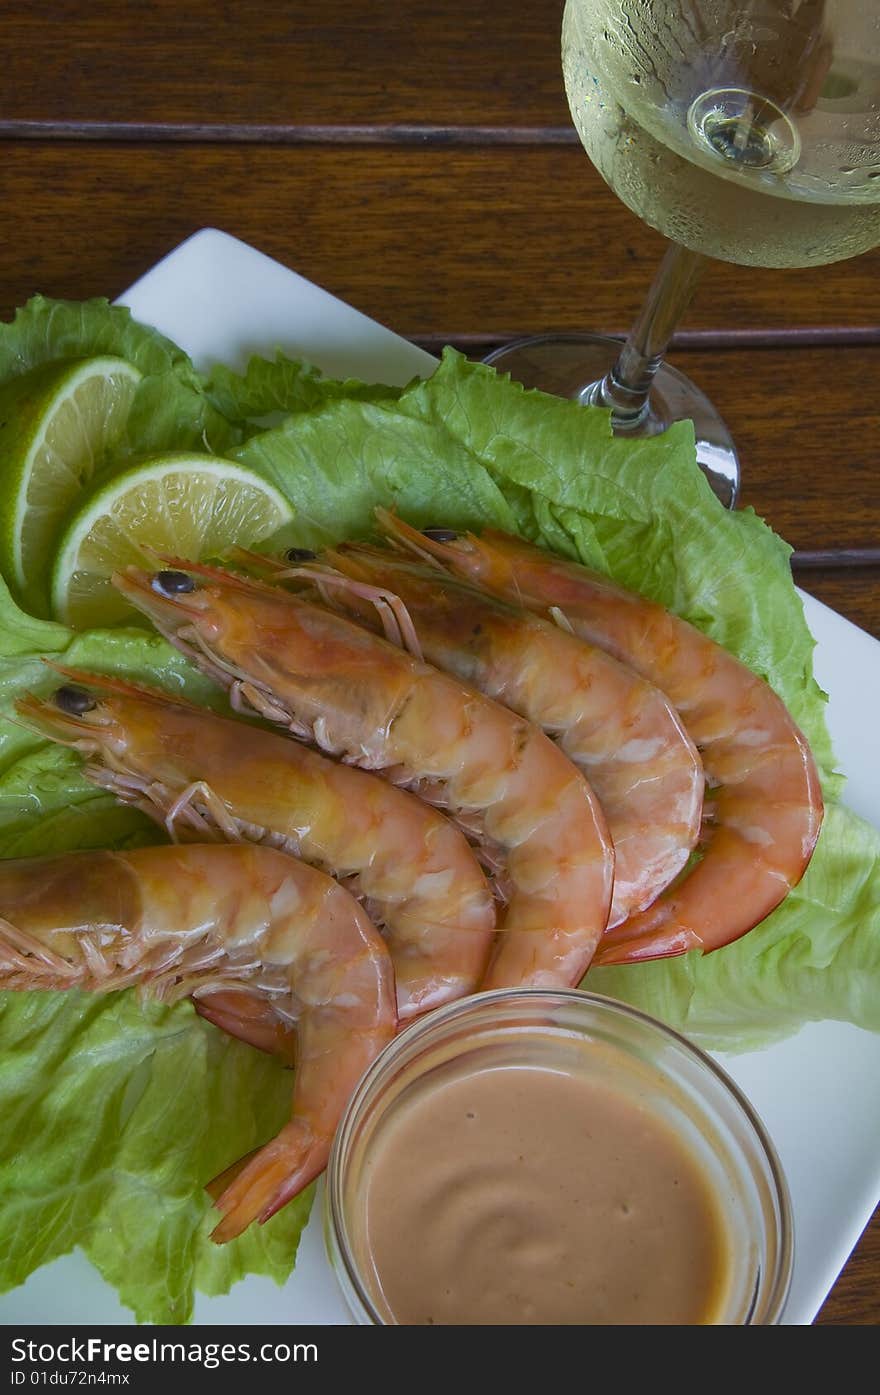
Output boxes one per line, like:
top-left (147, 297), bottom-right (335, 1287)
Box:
top-left (3, 0), bottom-right (570, 127)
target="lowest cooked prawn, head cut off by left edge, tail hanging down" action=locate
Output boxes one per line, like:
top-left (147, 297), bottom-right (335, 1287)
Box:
top-left (0, 844), bottom-right (396, 1242)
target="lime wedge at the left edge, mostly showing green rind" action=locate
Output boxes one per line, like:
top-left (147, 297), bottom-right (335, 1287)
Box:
top-left (0, 357), bottom-right (141, 611)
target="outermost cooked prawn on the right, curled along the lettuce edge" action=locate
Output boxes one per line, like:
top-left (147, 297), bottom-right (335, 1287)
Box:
top-left (379, 512), bottom-right (823, 964)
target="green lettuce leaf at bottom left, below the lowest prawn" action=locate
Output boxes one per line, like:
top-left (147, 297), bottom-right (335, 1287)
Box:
top-left (0, 990), bottom-right (311, 1322)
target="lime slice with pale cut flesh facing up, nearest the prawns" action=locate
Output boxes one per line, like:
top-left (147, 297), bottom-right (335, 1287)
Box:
top-left (52, 453), bottom-right (293, 629)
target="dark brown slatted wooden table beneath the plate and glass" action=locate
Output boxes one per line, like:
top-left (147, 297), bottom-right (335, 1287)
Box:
top-left (0, 0), bottom-right (880, 1324)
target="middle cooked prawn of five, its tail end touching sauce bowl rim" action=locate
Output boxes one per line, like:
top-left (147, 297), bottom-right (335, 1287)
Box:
top-left (113, 562), bottom-right (614, 988)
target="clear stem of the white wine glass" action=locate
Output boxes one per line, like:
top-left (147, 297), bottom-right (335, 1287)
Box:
top-left (580, 243), bottom-right (708, 431)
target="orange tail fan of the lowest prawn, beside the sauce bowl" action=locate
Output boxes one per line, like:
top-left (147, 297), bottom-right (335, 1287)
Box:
top-left (208, 1119), bottom-right (331, 1244)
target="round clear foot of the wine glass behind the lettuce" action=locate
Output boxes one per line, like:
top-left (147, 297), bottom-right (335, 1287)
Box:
top-left (484, 335), bottom-right (739, 509)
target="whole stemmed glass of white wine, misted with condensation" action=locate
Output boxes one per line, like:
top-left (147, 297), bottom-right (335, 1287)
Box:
top-left (485, 0), bottom-right (880, 508)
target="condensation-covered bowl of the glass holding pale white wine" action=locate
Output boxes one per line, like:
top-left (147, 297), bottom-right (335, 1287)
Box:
top-left (562, 0), bottom-right (880, 266)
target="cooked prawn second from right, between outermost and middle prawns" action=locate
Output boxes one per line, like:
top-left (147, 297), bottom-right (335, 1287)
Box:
top-left (264, 520), bottom-right (703, 926)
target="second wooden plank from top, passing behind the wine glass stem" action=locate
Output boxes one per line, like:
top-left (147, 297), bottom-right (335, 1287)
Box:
top-left (0, 141), bottom-right (880, 337)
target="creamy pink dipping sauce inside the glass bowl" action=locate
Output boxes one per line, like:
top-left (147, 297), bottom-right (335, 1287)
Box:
top-left (351, 1066), bottom-right (728, 1325)
